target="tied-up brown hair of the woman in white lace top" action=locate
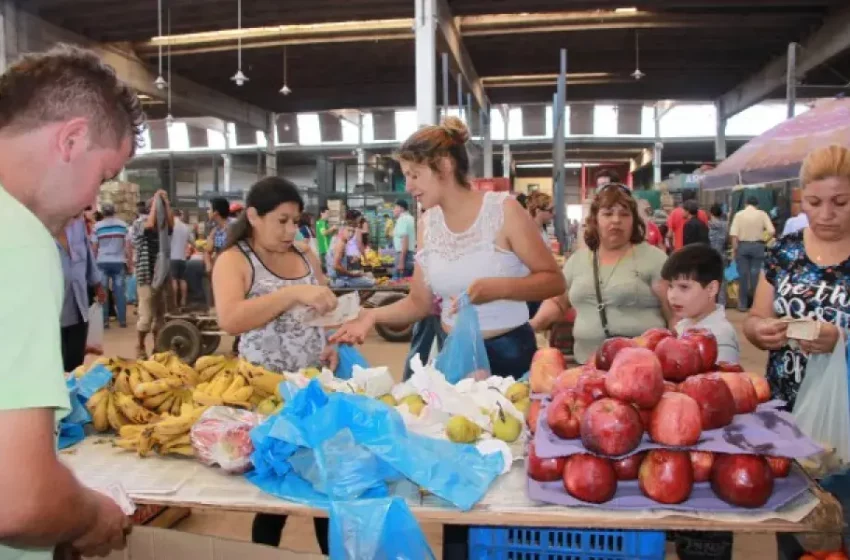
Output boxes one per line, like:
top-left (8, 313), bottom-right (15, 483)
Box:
top-left (395, 117), bottom-right (469, 187)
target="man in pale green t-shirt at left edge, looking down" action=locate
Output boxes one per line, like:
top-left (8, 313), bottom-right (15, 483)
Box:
top-left (0, 45), bottom-right (144, 560)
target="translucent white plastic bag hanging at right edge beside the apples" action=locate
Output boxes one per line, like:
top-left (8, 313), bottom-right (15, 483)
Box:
top-left (792, 329), bottom-right (850, 464)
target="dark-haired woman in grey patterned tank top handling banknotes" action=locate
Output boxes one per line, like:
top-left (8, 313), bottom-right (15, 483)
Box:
top-left (213, 177), bottom-right (338, 555)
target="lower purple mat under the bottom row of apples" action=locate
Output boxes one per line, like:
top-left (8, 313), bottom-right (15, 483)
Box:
top-left (528, 468), bottom-right (809, 513)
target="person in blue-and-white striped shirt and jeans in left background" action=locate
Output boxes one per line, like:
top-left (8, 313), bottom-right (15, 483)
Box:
top-left (92, 204), bottom-right (131, 329)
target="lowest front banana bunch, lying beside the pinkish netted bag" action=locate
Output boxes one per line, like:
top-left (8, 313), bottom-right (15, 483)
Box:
top-left (114, 403), bottom-right (206, 457)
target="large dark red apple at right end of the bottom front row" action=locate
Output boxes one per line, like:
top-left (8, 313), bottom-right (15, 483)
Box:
top-left (711, 455), bottom-right (773, 508)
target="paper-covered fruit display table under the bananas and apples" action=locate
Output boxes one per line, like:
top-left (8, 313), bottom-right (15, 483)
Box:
top-left (60, 436), bottom-right (844, 549)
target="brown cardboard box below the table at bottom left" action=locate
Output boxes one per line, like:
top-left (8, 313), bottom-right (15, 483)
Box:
top-left (94, 527), bottom-right (325, 560)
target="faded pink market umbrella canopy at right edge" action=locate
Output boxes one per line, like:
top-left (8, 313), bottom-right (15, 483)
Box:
top-left (702, 99), bottom-right (850, 190)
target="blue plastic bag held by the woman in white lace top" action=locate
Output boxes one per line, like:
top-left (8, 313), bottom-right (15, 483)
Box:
top-left (435, 293), bottom-right (490, 384)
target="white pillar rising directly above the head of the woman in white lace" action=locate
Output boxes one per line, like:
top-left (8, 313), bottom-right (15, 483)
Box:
top-left (413, 0), bottom-right (437, 126)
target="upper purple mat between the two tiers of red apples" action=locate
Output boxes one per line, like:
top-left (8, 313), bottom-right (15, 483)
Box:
top-left (534, 399), bottom-right (823, 459)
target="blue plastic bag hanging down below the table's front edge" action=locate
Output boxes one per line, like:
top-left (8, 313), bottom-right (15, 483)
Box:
top-left (329, 498), bottom-right (434, 560)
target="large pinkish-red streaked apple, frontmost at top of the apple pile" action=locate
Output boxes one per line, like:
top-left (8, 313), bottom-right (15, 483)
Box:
top-left (605, 348), bottom-right (664, 408)
